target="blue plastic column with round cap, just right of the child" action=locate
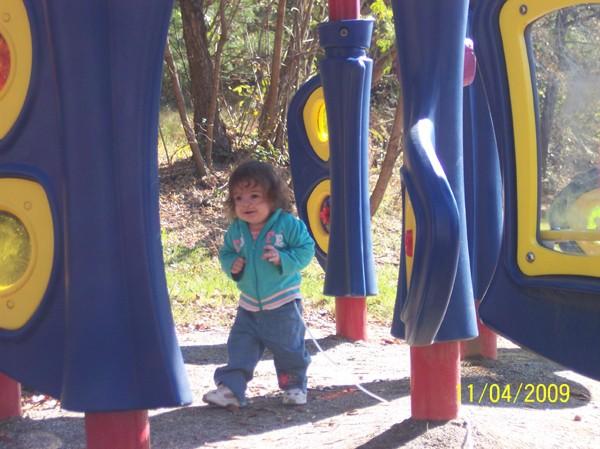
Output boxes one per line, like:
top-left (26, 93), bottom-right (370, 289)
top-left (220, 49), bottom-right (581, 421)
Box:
top-left (319, 19), bottom-right (377, 297)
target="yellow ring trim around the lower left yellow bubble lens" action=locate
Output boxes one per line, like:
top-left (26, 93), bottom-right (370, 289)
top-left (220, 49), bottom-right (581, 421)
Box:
top-left (0, 178), bottom-right (54, 330)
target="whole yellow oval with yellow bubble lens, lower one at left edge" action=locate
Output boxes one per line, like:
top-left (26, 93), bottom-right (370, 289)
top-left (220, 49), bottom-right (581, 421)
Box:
top-left (0, 178), bottom-right (54, 330)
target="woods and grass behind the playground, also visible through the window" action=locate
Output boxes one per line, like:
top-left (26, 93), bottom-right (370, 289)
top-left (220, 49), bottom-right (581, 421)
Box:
top-left (159, 0), bottom-right (600, 325)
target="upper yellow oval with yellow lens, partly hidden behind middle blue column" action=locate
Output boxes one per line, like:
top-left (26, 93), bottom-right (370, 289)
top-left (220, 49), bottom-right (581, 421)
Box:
top-left (302, 87), bottom-right (329, 162)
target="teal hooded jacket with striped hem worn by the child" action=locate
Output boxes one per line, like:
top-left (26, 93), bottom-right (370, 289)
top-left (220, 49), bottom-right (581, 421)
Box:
top-left (219, 209), bottom-right (315, 312)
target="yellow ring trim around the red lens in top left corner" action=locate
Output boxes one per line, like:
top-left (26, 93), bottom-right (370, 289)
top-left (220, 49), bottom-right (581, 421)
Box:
top-left (0, 0), bottom-right (33, 139)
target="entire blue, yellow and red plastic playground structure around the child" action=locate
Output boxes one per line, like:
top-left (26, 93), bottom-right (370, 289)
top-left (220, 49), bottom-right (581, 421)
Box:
top-left (0, 0), bottom-right (600, 448)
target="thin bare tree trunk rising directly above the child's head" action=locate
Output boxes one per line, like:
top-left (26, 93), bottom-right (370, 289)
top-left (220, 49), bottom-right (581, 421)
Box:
top-left (259, 0), bottom-right (286, 140)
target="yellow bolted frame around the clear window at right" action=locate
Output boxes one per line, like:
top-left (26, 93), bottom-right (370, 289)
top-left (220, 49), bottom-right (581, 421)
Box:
top-left (500, 0), bottom-right (600, 277)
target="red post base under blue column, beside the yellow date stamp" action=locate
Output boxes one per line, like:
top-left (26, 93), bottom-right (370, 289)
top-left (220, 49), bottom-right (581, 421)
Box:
top-left (410, 342), bottom-right (460, 421)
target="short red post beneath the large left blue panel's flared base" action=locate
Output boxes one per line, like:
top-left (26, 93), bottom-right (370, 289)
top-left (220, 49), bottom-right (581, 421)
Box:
top-left (85, 410), bottom-right (150, 449)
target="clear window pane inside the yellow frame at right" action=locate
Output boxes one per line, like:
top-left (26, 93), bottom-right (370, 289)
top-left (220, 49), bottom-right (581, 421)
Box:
top-left (528, 4), bottom-right (600, 255)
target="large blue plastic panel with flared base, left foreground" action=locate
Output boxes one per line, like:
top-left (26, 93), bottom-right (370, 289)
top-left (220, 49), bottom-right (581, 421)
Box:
top-left (0, 0), bottom-right (191, 412)
